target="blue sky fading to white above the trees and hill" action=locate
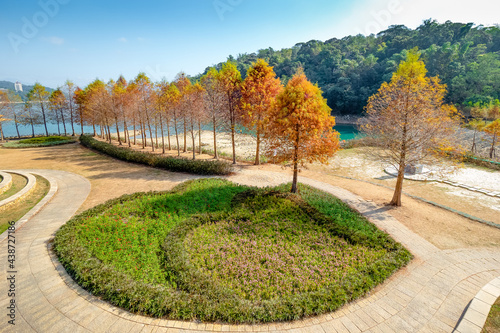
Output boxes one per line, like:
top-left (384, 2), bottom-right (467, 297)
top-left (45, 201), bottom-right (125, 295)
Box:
top-left (0, 0), bottom-right (500, 88)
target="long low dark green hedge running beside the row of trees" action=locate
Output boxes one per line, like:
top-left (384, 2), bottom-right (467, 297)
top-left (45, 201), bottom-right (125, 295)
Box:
top-left (80, 135), bottom-right (232, 175)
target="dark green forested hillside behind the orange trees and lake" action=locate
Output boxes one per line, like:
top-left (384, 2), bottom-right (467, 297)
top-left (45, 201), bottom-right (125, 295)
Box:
top-left (199, 20), bottom-right (500, 114)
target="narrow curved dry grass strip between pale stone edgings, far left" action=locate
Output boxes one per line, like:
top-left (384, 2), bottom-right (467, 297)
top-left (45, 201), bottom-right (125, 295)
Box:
top-left (0, 175), bottom-right (50, 233)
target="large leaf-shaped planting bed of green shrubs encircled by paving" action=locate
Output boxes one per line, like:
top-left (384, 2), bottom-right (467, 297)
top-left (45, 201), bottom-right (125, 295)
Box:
top-left (54, 179), bottom-right (411, 323)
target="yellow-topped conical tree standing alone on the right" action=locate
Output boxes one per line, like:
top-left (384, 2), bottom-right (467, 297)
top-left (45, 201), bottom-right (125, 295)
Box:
top-left (361, 50), bottom-right (460, 206)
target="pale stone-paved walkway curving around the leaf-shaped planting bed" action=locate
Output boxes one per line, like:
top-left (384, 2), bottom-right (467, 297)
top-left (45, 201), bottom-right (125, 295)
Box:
top-left (0, 170), bottom-right (500, 333)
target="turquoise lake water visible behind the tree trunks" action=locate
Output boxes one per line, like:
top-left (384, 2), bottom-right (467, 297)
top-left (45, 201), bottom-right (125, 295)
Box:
top-left (2, 122), bottom-right (359, 140)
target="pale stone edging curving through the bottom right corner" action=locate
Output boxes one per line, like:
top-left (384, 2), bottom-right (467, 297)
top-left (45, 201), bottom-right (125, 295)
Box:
top-left (453, 277), bottom-right (500, 333)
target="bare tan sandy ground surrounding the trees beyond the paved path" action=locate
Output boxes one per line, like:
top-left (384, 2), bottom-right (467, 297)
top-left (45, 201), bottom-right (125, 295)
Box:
top-left (0, 136), bottom-right (500, 249)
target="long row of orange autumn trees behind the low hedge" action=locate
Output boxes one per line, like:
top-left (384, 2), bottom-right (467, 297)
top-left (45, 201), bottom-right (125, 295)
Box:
top-left (2, 59), bottom-right (339, 192)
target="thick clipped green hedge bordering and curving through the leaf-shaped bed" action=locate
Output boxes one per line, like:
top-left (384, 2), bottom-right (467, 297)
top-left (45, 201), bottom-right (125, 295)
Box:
top-left (54, 179), bottom-right (412, 323)
